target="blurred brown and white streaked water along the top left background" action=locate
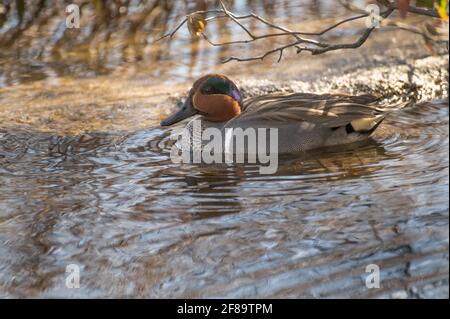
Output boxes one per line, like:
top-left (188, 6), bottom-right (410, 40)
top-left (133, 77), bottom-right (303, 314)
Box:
top-left (0, 0), bottom-right (365, 87)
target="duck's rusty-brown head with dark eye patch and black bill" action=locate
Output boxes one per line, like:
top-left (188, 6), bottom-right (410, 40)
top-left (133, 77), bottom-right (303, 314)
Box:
top-left (161, 74), bottom-right (242, 126)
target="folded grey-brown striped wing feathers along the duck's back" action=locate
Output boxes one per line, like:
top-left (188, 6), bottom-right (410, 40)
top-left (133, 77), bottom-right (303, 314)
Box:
top-left (232, 93), bottom-right (400, 130)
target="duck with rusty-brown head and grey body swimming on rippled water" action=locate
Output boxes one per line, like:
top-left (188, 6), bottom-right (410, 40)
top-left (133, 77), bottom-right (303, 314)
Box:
top-left (160, 74), bottom-right (399, 153)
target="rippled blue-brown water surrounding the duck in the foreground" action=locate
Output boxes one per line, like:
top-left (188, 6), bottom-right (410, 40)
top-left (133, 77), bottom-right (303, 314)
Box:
top-left (0, 0), bottom-right (449, 298)
